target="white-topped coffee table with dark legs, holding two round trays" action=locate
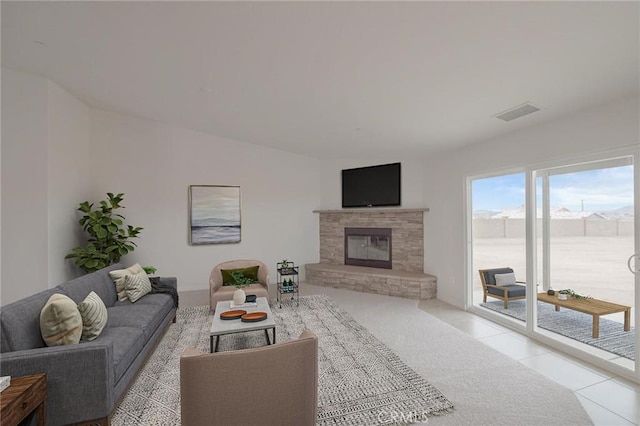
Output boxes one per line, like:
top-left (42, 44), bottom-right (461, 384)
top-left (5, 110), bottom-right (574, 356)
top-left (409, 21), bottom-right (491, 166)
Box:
top-left (209, 297), bottom-right (276, 353)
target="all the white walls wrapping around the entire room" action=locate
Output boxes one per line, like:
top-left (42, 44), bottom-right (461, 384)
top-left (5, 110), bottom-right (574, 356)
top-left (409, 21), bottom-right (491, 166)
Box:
top-left (0, 69), bottom-right (640, 306)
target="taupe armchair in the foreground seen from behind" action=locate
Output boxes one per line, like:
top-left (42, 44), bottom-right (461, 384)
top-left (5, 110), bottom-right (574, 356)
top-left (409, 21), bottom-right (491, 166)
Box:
top-left (180, 330), bottom-right (318, 426)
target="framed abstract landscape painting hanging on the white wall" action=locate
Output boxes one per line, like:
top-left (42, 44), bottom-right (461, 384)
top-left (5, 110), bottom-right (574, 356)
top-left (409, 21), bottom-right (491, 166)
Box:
top-left (189, 185), bottom-right (240, 244)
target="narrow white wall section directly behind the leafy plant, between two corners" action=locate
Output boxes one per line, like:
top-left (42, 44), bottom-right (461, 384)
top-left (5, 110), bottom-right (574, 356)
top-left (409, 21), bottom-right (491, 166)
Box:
top-left (47, 82), bottom-right (91, 287)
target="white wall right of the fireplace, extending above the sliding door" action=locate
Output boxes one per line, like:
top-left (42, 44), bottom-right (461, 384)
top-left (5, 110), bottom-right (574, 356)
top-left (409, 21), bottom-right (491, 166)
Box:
top-left (424, 97), bottom-right (640, 307)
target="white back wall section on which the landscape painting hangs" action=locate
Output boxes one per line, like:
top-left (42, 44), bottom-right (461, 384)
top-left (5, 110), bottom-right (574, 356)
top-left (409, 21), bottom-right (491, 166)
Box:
top-left (91, 110), bottom-right (321, 292)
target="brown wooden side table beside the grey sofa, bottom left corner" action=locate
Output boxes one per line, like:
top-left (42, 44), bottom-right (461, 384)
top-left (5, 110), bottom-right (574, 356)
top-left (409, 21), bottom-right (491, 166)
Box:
top-left (0, 374), bottom-right (47, 426)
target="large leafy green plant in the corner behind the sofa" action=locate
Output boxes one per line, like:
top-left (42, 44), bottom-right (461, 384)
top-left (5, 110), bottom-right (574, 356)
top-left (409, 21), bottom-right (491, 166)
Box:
top-left (65, 192), bottom-right (143, 272)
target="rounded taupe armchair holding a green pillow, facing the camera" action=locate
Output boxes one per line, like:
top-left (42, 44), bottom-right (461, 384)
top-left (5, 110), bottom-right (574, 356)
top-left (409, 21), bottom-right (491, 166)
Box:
top-left (209, 260), bottom-right (269, 311)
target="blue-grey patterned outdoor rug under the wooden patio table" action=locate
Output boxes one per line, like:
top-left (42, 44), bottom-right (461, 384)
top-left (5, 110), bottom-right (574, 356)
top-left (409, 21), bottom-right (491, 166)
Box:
top-left (480, 300), bottom-right (636, 360)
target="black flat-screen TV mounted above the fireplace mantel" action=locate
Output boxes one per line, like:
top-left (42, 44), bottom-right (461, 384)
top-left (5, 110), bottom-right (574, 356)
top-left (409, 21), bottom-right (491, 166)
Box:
top-left (342, 163), bottom-right (400, 207)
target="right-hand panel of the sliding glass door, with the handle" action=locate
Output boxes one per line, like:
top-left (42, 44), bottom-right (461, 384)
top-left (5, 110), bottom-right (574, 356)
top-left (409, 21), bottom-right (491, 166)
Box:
top-left (535, 156), bottom-right (636, 368)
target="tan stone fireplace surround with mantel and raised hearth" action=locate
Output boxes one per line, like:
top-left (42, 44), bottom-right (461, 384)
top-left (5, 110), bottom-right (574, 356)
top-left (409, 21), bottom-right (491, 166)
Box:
top-left (305, 208), bottom-right (437, 299)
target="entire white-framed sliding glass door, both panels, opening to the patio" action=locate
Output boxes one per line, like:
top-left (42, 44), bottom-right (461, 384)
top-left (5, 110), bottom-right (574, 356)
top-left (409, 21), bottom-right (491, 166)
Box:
top-left (467, 150), bottom-right (640, 379)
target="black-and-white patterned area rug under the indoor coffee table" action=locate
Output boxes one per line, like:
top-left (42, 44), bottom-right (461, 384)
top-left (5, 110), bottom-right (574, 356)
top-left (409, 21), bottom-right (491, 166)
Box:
top-left (112, 295), bottom-right (453, 426)
